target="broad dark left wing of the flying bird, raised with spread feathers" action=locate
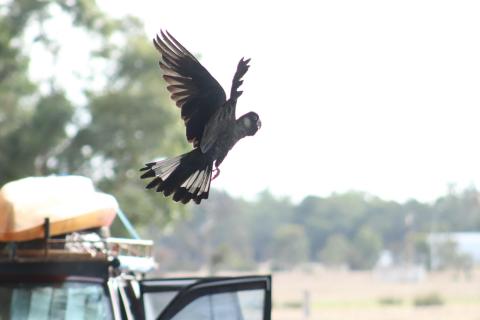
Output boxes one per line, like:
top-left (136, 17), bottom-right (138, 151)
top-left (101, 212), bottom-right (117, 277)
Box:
top-left (153, 31), bottom-right (226, 147)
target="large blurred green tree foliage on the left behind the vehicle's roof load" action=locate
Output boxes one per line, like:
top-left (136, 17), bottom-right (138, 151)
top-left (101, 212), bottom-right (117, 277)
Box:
top-left (0, 0), bottom-right (187, 230)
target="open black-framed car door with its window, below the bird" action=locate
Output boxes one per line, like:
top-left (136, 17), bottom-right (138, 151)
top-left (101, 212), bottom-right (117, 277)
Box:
top-left (140, 276), bottom-right (271, 320)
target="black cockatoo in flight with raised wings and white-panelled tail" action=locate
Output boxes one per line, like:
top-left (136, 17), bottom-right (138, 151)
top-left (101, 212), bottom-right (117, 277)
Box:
top-left (140, 31), bottom-right (261, 204)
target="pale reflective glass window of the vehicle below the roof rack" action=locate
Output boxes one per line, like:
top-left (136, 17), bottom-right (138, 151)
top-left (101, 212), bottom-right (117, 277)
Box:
top-left (0, 282), bottom-right (112, 320)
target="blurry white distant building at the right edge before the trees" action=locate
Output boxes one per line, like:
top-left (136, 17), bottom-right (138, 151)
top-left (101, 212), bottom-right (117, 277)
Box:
top-left (427, 232), bottom-right (480, 269)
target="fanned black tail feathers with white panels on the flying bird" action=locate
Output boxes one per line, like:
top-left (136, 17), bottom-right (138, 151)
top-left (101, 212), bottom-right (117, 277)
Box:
top-left (140, 148), bottom-right (213, 204)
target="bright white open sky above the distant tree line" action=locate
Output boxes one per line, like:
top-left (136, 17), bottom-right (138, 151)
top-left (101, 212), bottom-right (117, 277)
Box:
top-left (37, 0), bottom-right (480, 201)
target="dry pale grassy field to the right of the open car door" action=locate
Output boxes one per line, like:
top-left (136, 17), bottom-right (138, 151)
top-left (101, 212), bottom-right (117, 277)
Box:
top-left (272, 270), bottom-right (480, 320)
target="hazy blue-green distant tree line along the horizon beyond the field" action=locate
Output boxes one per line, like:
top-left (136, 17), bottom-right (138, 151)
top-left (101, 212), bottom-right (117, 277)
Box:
top-left (154, 187), bottom-right (480, 270)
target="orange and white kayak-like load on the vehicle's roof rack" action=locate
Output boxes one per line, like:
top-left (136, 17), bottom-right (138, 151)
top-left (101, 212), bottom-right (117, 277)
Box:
top-left (0, 176), bottom-right (118, 242)
